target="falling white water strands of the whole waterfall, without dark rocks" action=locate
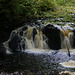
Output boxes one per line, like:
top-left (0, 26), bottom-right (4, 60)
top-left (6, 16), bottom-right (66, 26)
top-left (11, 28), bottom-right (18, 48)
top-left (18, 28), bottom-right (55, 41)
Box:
top-left (4, 25), bottom-right (74, 51)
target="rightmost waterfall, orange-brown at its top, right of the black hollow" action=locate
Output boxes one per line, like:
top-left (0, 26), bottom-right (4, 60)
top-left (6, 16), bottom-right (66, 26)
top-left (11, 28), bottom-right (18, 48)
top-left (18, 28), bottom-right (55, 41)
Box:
top-left (60, 30), bottom-right (74, 49)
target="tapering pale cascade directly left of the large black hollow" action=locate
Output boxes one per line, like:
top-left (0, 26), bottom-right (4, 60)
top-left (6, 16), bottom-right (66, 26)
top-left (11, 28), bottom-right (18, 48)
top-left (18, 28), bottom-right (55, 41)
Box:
top-left (34, 30), bottom-right (48, 49)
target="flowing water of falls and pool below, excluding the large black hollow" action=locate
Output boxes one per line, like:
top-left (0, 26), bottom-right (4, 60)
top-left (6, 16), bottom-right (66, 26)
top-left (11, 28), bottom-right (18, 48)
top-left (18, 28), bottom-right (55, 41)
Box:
top-left (0, 17), bottom-right (75, 72)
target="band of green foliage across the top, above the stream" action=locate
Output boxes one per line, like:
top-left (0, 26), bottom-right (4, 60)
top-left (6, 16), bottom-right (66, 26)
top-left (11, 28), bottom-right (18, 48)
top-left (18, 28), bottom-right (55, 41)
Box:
top-left (0, 0), bottom-right (75, 23)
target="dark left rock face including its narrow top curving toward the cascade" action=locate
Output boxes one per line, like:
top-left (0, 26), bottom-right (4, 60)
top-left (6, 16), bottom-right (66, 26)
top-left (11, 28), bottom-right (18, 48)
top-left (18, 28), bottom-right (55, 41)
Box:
top-left (8, 27), bottom-right (28, 52)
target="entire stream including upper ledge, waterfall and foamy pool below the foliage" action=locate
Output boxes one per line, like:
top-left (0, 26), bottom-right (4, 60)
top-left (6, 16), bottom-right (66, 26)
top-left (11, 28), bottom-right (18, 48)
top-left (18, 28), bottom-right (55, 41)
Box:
top-left (0, 18), bottom-right (75, 75)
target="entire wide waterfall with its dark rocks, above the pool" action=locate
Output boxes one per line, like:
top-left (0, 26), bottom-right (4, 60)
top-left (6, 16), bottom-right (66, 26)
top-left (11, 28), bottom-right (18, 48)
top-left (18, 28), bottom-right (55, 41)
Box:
top-left (4, 24), bottom-right (74, 52)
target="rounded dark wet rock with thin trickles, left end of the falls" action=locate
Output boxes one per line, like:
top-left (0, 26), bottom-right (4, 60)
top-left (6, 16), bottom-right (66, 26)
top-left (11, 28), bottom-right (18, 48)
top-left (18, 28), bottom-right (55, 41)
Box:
top-left (8, 33), bottom-right (25, 52)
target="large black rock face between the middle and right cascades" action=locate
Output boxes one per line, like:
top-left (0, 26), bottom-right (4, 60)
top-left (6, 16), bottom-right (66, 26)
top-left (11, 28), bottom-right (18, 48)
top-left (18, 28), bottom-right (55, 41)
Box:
top-left (43, 24), bottom-right (61, 50)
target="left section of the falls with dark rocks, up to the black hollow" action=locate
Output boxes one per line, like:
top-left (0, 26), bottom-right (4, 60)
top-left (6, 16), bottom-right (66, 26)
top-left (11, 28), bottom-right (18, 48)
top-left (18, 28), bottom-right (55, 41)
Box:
top-left (4, 26), bottom-right (48, 52)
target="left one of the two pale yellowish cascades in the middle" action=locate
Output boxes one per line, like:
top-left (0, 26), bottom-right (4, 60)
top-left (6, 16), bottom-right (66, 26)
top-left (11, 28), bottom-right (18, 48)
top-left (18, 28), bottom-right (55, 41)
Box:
top-left (23, 27), bottom-right (34, 49)
